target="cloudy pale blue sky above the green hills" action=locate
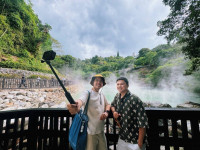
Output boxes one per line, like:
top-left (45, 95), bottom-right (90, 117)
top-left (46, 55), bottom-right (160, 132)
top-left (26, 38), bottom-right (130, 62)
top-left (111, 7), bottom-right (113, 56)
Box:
top-left (31, 0), bottom-right (170, 59)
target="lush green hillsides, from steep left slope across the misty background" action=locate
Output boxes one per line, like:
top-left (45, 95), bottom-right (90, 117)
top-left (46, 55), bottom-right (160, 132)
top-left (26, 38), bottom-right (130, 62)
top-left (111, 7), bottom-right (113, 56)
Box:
top-left (0, 0), bottom-right (200, 96)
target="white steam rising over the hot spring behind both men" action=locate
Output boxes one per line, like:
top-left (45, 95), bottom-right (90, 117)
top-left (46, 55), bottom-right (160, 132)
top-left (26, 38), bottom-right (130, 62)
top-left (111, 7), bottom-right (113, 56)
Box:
top-left (61, 59), bottom-right (200, 107)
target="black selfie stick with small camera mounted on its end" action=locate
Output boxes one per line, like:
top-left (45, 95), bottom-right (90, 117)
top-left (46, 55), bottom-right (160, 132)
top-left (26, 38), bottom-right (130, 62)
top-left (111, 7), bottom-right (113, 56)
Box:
top-left (41, 50), bottom-right (76, 104)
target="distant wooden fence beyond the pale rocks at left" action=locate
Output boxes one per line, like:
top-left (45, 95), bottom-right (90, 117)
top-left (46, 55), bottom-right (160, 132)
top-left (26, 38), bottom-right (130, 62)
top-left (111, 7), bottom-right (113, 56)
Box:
top-left (0, 78), bottom-right (72, 89)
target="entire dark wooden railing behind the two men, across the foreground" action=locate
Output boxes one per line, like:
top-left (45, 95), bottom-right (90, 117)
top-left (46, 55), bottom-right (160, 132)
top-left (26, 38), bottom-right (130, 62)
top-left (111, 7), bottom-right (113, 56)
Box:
top-left (0, 108), bottom-right (200, 150)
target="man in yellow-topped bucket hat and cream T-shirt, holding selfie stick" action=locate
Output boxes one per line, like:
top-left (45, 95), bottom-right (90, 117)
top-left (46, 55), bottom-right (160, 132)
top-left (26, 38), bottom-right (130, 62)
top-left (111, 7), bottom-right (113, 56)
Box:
top-left (67, 74), bottom-right (110, 150)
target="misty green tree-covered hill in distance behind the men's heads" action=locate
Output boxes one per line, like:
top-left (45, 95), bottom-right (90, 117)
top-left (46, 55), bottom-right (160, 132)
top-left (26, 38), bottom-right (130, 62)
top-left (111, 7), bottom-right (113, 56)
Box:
top-left (52, 44), bottom-right (200, 94)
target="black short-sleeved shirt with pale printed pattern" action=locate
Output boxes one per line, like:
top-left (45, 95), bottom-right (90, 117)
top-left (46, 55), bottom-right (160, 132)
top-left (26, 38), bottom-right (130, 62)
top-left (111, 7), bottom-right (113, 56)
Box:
top-left (111, 91), bottom-right (148, 144)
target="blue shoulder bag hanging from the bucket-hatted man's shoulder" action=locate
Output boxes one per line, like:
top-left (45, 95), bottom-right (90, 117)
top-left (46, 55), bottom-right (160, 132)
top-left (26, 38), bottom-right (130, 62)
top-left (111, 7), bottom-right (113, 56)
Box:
top-left (69, 91), bottom-right (90, 150)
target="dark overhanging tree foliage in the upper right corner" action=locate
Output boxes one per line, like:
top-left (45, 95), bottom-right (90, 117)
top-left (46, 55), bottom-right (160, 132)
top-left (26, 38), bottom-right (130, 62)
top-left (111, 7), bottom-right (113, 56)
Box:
top-left (158, 0), bottom-right (200, 72)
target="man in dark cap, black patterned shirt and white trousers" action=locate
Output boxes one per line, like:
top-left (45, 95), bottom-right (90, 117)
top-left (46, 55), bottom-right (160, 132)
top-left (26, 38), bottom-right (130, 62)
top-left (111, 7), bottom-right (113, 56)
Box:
top-left (111, 77), bottom-right (148, 150)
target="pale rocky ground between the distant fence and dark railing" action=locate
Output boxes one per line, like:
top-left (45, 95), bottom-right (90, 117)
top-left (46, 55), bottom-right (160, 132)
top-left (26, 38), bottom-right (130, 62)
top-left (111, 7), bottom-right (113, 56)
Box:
top-left (0, 88), bottom-right (77, 111)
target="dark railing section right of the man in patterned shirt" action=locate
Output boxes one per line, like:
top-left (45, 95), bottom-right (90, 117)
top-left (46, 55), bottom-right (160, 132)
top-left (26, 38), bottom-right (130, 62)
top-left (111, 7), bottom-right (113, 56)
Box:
top-left (146, 108), bottom-right (200, 150)
